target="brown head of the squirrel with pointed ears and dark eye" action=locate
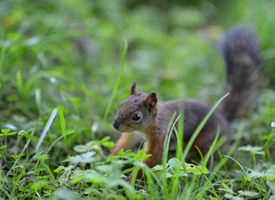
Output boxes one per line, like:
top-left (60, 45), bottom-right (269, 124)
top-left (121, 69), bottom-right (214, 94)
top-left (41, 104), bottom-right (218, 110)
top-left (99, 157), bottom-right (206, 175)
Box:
top-left (113, 81), bottom-right (158, 132)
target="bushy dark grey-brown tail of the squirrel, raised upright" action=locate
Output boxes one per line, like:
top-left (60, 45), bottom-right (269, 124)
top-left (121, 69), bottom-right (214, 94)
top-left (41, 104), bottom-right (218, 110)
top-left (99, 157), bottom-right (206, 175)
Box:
top-left (221, 27), bottom-right (261, 121)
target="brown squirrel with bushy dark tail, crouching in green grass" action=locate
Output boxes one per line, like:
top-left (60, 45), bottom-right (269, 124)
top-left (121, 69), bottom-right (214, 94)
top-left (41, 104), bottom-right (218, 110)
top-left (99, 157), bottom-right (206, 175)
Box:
top-left (111, 27), bottom-right (261, 181)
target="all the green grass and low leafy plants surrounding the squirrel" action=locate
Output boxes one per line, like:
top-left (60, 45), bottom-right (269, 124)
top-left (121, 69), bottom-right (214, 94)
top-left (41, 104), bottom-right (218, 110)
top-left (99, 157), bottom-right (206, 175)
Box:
top-left (0, 0), bottom-right (275, 199)
